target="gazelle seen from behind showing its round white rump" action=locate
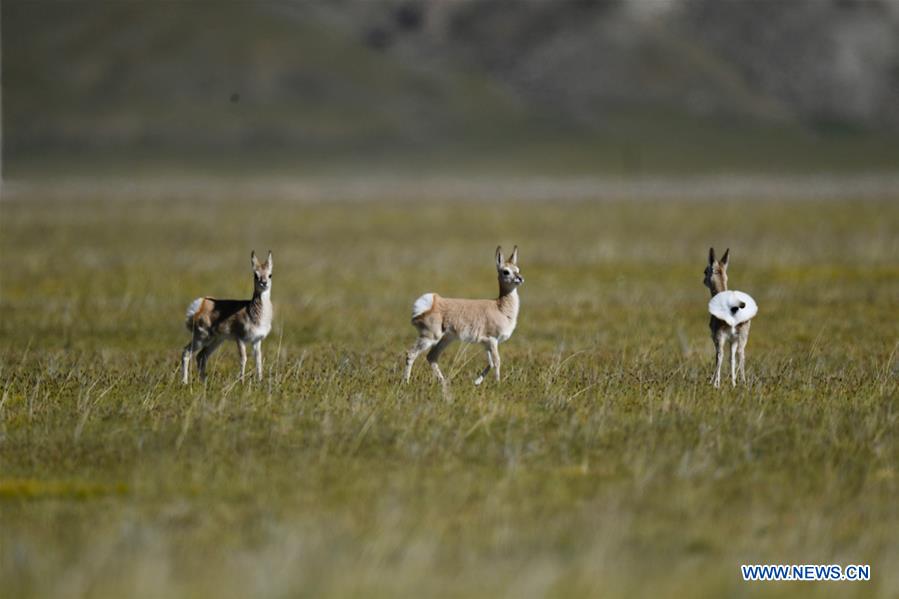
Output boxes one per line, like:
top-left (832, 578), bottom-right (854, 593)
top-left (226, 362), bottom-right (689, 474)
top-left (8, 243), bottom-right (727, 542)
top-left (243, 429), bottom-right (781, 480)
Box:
top-left (703, 248), bottom-right (758, 387)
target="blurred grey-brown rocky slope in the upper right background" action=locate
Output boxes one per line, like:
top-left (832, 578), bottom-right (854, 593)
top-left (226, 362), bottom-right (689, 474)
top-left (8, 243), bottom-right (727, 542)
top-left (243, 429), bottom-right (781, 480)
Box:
top-left (410, 0), bottom-right (899, 128)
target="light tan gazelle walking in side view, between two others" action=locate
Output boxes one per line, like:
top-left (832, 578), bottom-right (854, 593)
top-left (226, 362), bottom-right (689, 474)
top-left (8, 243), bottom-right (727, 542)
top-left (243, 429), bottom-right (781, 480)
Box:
top-left (403, 246), bottom-right (524, 385)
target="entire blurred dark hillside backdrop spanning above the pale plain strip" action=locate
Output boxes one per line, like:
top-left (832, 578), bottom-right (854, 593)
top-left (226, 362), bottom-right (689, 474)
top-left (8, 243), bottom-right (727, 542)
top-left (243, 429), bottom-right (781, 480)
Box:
top-left (2, 0), bottom-right (899, 172)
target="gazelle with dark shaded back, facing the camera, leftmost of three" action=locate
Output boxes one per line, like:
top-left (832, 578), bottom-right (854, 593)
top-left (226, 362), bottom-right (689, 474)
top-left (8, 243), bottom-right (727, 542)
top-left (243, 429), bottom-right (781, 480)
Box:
top-left (181, 251), bottom-right (272, 384)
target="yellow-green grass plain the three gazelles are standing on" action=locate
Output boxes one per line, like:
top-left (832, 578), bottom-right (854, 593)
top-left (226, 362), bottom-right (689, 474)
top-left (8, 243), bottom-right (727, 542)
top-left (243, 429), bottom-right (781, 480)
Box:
top-left (0, 185), bottom-right (899, 598)
